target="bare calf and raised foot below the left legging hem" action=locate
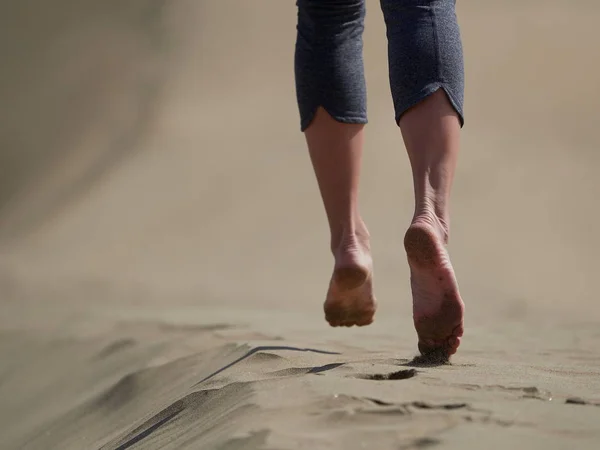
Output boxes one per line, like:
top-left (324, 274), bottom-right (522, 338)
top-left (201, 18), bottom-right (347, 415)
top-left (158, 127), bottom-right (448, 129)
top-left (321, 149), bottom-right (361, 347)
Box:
top-left (305, 108), bottom-right (376, 326)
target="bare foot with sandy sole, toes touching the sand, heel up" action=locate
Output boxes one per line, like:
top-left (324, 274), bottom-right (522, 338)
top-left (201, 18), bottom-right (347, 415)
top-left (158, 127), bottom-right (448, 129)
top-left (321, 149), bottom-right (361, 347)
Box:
top-left (404, 218), bottom-right (464, 357)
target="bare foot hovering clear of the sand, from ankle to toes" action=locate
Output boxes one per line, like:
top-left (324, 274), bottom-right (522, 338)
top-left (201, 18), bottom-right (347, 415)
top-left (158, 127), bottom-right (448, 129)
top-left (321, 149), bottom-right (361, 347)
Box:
top-left (324, 239), bottom-right (377, 327)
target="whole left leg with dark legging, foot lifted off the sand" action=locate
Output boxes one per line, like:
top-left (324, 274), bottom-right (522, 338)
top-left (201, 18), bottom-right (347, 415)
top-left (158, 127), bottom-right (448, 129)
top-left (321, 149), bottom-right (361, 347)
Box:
top-left (295, 0), bottom-right (375, 326)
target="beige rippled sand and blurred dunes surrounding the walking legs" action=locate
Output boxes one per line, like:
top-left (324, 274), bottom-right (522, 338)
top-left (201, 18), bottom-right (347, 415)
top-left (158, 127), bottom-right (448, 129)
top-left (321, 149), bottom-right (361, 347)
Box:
top-left (0, 0), bottom-right (600, 450)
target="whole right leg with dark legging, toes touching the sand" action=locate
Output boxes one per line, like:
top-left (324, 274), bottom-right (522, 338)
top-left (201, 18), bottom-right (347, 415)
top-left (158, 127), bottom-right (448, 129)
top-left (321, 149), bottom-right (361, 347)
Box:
top-left (381, 0), bottom-right (464, 356)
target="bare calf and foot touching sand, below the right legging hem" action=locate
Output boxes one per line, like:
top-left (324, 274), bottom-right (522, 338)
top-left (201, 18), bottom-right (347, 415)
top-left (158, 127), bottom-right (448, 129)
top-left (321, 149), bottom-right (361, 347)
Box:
top-left (400, 89), bottom-right (464, 355)
